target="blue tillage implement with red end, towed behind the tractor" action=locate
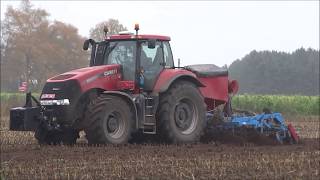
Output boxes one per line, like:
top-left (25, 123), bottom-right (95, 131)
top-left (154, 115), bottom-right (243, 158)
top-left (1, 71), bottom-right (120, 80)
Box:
top-left (207, 112), bottom-right (299, 144)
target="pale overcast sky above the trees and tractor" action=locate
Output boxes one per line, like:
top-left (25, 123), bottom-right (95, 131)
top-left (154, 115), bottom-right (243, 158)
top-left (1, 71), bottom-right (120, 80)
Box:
top-left (1, 0), bottom-right (319, 66)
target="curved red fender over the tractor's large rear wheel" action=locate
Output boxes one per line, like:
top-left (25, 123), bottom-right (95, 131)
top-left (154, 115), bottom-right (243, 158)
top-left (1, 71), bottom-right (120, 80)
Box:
top-left (153, 69), bottom-right (205, 94)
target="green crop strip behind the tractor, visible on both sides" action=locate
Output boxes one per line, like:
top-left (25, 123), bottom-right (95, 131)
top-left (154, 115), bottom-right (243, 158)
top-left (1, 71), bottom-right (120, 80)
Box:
top-left (1, 93), bottom-right (320, 116)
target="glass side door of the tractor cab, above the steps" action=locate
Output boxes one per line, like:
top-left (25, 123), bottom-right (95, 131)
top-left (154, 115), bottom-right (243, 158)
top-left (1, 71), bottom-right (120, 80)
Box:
top-left (140, 41), bottom-right (164, 91)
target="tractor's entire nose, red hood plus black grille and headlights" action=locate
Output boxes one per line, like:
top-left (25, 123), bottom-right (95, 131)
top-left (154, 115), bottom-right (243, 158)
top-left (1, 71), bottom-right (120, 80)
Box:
top-left (40, 64), bottom-right (122, 126)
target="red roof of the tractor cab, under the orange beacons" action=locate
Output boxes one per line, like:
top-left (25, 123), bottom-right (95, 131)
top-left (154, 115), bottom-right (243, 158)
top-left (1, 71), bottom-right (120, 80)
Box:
top-left (106, 33), bottom-right (171, 41)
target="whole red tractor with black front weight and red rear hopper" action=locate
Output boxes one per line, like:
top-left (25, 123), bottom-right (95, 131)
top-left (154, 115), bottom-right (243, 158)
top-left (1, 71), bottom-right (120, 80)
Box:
top-left (10, 26), bottom-right (238, 144)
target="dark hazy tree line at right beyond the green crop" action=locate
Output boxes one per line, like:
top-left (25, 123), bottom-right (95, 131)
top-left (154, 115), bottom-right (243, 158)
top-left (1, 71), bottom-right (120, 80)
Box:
top-left (229, 48), bottom-right (320, 95)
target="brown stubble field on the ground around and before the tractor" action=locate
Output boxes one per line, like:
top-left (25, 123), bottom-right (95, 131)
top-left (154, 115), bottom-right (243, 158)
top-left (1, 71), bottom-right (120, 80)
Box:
top-left (0, 117), bottom-right (320, 179)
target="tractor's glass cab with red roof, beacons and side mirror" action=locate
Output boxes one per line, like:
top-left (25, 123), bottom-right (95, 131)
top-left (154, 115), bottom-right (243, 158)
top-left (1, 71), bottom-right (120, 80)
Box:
top-left (83, 26), bottom-right (174, 91)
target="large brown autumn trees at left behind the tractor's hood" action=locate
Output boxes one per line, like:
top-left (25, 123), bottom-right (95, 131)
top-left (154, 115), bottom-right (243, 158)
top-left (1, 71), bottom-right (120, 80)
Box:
top-left (1, 0), bottom-right (88, 91)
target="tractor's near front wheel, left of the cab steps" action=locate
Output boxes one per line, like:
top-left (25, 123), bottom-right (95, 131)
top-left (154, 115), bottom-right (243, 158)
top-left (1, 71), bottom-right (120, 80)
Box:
top-left (84, 95), bottom-right (134, 144)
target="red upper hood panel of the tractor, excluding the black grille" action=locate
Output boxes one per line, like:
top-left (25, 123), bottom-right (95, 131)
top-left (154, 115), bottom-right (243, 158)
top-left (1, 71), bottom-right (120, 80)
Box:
top-left (47, 64), bottom-right (122, 91)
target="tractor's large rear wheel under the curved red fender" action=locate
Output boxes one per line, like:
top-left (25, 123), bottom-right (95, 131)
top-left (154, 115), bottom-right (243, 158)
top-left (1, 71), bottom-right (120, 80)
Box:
top-left (157, 81), bottom-right (206, 143)
